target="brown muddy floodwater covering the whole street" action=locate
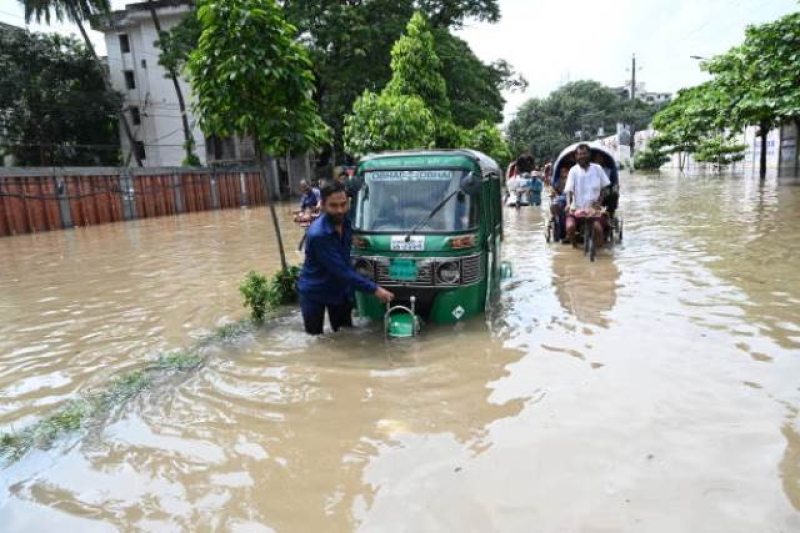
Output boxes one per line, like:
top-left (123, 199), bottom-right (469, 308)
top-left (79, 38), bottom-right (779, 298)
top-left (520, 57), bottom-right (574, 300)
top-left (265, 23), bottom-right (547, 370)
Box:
top-left (0, 174), bottom-right (800, 532)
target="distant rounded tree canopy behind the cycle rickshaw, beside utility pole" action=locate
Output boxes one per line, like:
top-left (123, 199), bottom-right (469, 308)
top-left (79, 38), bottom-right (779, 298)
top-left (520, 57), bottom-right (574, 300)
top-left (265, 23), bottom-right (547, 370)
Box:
top-left (508, 80), bottom-right (657, 160)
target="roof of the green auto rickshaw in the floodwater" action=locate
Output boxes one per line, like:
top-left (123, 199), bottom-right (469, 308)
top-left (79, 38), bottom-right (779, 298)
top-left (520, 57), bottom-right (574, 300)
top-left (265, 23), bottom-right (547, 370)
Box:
top-left (358, 150), bottom-right (501, 179)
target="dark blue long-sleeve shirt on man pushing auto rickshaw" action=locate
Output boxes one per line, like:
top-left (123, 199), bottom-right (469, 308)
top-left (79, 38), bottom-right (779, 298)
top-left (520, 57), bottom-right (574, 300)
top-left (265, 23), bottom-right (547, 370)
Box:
top-left (297, 215), bottom-right (378, 305)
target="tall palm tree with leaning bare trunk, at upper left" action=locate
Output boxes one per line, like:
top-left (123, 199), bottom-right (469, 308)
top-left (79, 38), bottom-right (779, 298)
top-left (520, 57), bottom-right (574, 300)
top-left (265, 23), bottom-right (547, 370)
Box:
top-left (19, 0), bottom-right (142, 166)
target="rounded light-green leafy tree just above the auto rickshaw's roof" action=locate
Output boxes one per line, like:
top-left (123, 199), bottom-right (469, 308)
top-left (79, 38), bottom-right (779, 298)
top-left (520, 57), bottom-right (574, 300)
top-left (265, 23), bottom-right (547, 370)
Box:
top-left (344, 91), bottom-right (435, 157)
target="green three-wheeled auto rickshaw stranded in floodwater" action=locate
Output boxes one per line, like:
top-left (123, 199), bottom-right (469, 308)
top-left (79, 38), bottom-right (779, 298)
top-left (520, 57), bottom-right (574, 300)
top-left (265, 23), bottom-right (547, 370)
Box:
top-left (351, 150), bottom-right (503, 336)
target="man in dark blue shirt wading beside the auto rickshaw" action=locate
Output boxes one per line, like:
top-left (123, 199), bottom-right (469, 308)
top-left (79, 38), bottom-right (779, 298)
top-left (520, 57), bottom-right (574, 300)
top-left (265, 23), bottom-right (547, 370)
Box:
top-left (297, 181), bottom-right (394, 335)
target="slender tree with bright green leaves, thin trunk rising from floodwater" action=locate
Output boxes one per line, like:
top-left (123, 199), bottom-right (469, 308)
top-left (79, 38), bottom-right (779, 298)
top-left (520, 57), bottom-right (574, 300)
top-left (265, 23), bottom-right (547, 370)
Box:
top-left (187, 0), bottom-right (328, 270)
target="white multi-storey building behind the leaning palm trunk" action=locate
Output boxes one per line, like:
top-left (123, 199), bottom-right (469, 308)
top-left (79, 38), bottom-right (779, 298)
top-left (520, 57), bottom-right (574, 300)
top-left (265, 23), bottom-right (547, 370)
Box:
top-left (92, 0), bottom-right (206, 167)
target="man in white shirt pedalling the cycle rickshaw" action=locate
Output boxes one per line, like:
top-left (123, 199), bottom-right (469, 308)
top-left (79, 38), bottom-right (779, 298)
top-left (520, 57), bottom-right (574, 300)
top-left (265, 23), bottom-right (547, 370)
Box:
top-left (564, 144), bottom-right (611, 249)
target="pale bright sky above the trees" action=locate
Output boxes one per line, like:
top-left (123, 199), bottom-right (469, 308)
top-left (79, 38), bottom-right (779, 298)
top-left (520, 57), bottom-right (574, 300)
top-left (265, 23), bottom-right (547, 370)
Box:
top-left (0, 0), bottom-right (800, 118)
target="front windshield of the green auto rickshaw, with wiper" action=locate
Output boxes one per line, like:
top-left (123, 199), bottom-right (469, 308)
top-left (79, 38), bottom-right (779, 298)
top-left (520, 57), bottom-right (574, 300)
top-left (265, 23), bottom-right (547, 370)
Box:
top-left (352, 169), bottom-right (478, 233)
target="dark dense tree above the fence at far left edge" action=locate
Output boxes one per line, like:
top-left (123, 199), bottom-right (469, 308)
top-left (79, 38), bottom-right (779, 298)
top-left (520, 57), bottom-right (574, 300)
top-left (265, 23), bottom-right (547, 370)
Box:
top-left (0, 30), bottom-right (122, 165)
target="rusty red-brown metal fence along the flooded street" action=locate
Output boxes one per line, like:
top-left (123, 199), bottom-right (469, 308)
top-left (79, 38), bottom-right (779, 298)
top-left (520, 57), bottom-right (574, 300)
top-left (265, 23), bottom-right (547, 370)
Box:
top-left (0, 168), bottom-right (266, 237)
